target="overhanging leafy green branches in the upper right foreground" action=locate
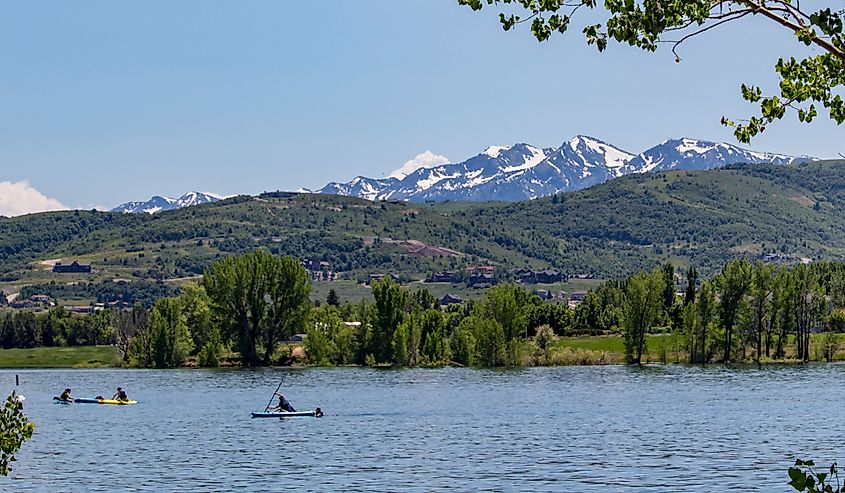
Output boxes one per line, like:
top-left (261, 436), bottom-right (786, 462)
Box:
top-left (458, 0), bottom-right (845, 143)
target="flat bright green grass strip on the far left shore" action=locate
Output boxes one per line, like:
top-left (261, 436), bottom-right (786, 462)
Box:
top-left (0, 346), bottom-right (115, 368)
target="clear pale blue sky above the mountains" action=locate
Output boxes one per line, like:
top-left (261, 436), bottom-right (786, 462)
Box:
top-left (0, 0), bottom-right (845, 213)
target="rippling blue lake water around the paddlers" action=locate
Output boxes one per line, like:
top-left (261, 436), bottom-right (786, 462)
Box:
top-left (0, 365), bottom-right (845, 492)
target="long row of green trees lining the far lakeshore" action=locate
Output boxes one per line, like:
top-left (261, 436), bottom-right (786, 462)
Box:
top-left (0, 250), bottom-right (845, 368)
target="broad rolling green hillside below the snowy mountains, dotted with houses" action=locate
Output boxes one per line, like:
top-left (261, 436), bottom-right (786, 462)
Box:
top-left (0, 161), bottom-right (845, 300)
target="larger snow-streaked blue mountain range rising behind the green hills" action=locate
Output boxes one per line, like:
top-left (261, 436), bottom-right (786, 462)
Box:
top-left (317, 135), bottom-right (813, 202)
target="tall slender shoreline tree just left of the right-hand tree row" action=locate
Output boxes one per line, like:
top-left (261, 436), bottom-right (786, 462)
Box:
top-left (624, 270), bottom-right (664, 365)
